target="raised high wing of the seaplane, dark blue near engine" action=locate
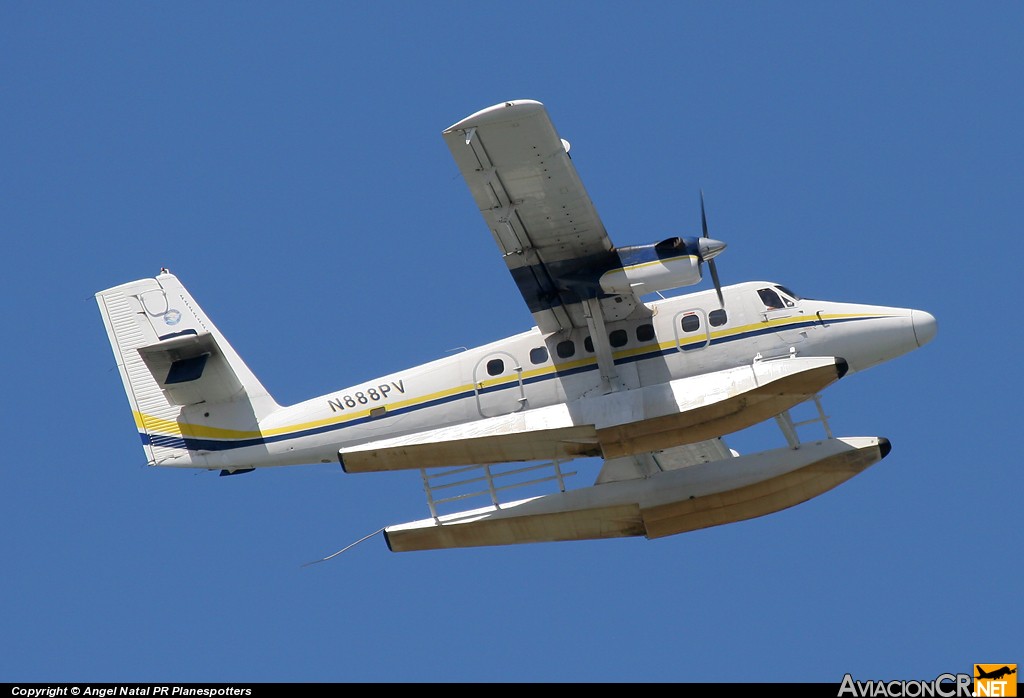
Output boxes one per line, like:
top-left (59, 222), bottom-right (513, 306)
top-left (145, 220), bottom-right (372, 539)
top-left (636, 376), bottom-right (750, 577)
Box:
top-left (443, 99), bottom-right (649, 334)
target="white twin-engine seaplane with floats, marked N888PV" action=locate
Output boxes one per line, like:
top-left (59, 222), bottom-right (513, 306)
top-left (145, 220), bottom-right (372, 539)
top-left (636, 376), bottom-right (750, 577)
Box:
top-left (96, 99), bottom-right (936, 552)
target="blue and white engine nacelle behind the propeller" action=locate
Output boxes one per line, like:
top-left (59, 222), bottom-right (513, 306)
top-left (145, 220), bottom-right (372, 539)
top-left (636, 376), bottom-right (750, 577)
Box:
top-left (600, 237), bottom-right (704, 296)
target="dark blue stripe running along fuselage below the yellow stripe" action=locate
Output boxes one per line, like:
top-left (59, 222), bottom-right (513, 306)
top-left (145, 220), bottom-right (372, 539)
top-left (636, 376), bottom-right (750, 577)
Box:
top-left (139, 315), bottom-right (881, 451)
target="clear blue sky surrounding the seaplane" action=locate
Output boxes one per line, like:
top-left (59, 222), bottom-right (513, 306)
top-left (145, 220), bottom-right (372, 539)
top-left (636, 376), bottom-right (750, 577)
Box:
top-left (0, 1), bottom-right (1024, 683)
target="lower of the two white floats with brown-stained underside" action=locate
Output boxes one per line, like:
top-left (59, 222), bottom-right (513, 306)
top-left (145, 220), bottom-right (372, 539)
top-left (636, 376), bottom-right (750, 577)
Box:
top-left (384, 437), bottom-right (890, 552)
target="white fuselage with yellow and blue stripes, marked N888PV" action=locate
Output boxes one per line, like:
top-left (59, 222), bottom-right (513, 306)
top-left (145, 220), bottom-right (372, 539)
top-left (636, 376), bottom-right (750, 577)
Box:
top-left (182, 281), bottom-right (935, 470)
